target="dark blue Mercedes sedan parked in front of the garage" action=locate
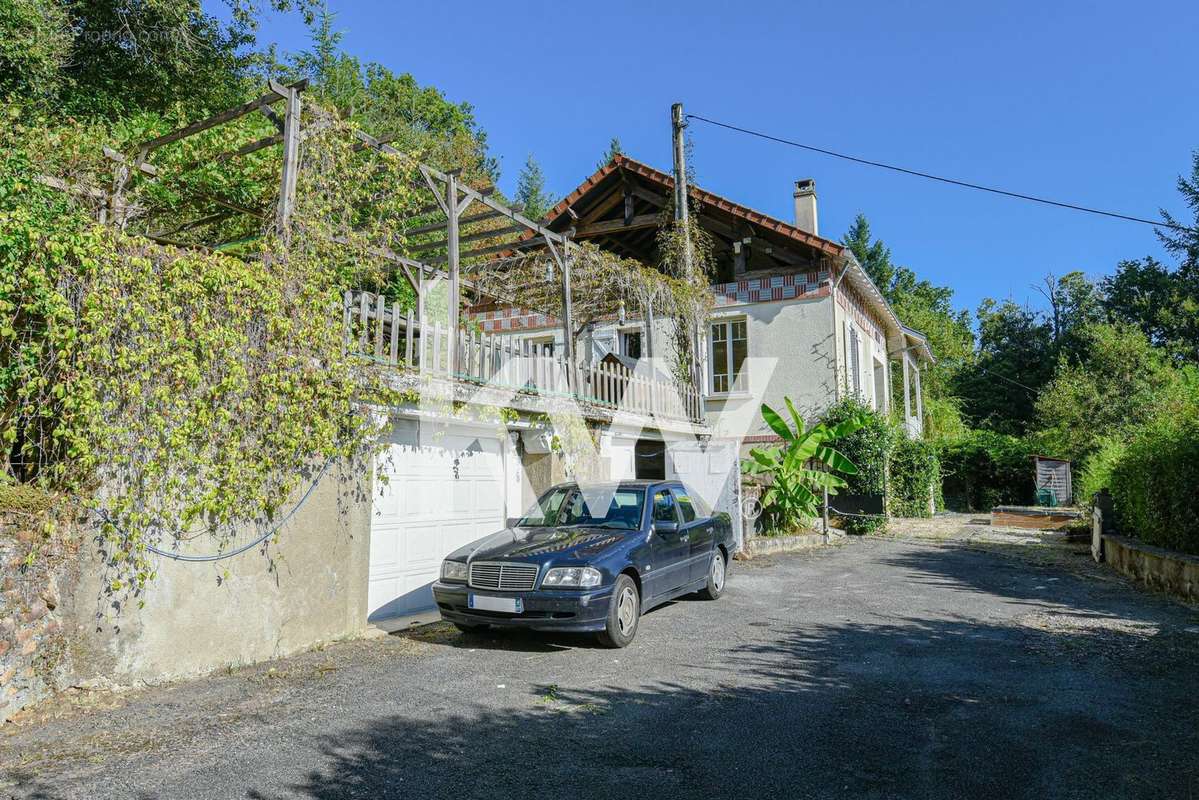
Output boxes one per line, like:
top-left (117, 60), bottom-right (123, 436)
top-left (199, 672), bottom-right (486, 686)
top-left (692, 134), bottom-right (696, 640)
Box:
top-left (433, 481), bottom-right (734, 648)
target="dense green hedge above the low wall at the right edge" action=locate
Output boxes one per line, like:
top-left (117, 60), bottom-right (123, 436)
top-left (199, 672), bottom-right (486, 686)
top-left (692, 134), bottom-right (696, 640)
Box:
top-left (1110, 414), bottom-right (1199, 554)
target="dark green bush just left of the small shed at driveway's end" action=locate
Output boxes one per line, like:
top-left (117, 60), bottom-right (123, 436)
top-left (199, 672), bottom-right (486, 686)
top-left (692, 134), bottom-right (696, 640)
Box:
top-left (938, 431), bottom-right (1035, 511)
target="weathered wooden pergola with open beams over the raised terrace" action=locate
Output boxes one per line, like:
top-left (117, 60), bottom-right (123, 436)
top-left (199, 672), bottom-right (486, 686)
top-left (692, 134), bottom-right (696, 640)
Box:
top-left (41, 80), bottom-right (703, 419)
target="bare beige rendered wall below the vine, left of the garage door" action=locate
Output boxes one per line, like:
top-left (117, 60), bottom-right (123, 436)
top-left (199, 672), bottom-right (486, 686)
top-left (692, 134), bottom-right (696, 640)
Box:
top-left (64, 467), bottom-right (370, 684)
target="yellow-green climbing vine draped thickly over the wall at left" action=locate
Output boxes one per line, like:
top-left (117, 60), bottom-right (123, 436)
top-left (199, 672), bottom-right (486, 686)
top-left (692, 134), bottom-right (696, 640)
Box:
top-left (0, 101), bottom-right (414, 589)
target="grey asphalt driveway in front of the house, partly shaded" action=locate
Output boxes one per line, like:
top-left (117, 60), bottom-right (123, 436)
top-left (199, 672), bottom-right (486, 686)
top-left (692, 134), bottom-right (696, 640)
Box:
top-left (0, 532), bottom-right (1199, 800)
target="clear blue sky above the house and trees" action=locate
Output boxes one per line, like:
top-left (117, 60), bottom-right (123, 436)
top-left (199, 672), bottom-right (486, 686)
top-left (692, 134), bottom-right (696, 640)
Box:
top-left (220, 0), bottom-right (1199, 309)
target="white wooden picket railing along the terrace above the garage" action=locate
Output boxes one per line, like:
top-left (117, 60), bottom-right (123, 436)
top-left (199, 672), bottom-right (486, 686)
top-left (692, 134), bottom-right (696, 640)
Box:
top-left (343, 291), bottom-right (704, 422)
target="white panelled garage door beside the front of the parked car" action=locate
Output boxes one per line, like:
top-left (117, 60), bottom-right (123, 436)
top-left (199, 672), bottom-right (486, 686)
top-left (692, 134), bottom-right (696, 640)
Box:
top-left (367, 421), bottom-right (505, 619)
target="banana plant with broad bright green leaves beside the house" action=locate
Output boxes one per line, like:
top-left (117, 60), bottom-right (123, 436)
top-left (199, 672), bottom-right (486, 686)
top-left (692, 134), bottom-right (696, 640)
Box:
top-left (742, 397), bottom-right (866, 530)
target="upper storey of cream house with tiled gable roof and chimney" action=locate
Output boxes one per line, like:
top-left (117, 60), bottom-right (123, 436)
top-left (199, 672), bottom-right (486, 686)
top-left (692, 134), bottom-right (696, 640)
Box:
top-left (481, 155), bottom-right (933, 445)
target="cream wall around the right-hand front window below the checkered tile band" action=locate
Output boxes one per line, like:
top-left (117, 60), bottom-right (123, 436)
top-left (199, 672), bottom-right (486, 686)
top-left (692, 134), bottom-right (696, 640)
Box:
top-left (705, 296), bottom-right (837, 437)
